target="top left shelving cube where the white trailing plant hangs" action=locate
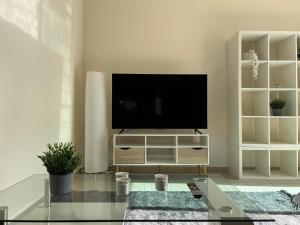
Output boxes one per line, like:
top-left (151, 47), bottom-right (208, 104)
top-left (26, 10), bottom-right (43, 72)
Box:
top-left (241, 34), bottom-right (268, 60)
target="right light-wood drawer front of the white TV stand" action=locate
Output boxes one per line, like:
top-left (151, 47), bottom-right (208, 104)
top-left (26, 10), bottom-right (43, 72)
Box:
top-left (178, 148), bottom-right (208, 165)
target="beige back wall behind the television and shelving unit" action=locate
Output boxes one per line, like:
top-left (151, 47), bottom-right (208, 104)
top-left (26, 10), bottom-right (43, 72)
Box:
top-left (83, 0), bottom-right (300, 166)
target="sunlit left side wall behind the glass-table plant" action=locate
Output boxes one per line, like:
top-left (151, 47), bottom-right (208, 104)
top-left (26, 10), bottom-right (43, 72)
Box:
top-left (0, 0), bottom-right (83, 190)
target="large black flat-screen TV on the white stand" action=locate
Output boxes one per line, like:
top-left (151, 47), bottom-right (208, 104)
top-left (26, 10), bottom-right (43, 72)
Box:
top-left (112, 74), bottom-right (207, 129)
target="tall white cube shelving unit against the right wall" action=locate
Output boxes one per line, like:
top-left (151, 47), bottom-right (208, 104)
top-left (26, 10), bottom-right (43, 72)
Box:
top-left (228, 31), bottom-right (300, 179)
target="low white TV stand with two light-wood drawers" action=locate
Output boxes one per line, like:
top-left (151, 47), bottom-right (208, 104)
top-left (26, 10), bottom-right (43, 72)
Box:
top-left (113, 133), bottom-right (209, 173)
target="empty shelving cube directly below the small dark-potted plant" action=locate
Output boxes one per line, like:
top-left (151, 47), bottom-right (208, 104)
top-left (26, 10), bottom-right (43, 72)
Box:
top-left (270, 117), bottom-right (297, 145)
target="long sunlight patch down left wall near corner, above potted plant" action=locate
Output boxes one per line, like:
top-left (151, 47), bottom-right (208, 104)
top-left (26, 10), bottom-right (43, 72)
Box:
top-left (39, 0), bottom-right (74, 141)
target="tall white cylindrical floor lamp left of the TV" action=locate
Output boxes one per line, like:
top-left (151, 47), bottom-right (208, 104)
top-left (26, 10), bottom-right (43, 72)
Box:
top-left (85, 72), bottom-right (108, 173)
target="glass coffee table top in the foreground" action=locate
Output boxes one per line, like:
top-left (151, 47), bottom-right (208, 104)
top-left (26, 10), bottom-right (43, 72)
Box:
top-left (0, 174), bottom-right (274, 225)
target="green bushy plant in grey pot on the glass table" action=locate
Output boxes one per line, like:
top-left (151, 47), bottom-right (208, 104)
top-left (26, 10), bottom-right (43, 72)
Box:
top-left (38, 142), bottom-right (81, 195)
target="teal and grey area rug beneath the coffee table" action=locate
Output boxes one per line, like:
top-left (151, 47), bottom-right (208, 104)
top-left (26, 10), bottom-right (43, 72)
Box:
top-left (124, 191), bottom-right (300, 225)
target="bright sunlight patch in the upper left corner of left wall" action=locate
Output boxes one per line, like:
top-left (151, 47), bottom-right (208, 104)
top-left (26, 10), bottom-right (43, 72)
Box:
top-left (0, 0), bottom-right (40, 39)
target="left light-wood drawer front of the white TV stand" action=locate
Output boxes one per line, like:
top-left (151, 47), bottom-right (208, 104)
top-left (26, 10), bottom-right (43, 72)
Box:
top-left (114, 148), bottom-right (145, 164)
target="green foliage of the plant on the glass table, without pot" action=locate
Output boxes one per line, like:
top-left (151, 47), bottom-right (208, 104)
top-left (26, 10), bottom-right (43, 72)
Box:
top-left (37, 142), bottom-right (81, 175)
